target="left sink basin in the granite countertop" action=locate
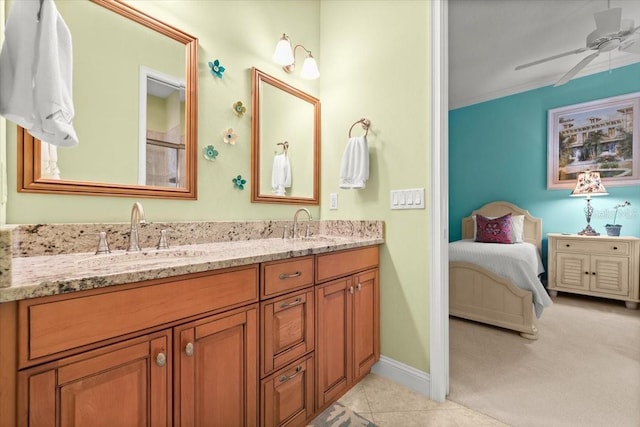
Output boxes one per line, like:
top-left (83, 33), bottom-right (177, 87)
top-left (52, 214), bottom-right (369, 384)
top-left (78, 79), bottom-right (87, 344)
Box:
top-left (76, 249), bottom-right (209, 268)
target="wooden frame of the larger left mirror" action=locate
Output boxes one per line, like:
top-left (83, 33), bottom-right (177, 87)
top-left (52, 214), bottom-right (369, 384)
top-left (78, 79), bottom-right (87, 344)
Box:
top-left (17, 0), bottom-right (198, 199)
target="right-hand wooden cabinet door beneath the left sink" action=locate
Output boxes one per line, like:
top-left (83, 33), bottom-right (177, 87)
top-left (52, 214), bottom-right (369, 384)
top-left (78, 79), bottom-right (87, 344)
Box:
top-left (174, 304), bottom-right (258, 427)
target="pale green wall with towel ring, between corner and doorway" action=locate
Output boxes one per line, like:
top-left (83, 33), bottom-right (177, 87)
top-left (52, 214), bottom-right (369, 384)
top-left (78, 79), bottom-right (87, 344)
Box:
top-left (319, 0), bottom-right (431, 371)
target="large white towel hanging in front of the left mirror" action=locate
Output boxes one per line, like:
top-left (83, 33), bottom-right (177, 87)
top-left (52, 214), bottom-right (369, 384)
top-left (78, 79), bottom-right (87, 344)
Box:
top-left (0, 0), bottom-right (78, 146)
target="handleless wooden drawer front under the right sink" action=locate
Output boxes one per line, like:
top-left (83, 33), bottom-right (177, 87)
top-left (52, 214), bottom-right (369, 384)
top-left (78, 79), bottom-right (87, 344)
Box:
top-left (316, 246), bottom-right (378, 283)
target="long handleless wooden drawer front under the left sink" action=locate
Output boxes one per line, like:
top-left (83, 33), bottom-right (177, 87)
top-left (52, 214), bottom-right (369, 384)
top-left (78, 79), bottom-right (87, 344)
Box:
top-left (19, 265), bottom-right (258, 364)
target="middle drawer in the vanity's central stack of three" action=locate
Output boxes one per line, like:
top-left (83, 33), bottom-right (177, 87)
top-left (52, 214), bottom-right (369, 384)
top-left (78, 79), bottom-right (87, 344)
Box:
top-left (260, 289), bottom-right (315, 376)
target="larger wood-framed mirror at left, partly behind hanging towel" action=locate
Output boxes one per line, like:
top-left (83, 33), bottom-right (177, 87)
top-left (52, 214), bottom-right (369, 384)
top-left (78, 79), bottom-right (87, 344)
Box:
top-left (17, 0), bottom-right (198, 199)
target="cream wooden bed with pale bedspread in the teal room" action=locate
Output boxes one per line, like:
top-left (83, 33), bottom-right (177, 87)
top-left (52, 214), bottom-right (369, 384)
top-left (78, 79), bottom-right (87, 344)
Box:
top-left (449, 201), bottom-right (552, 340)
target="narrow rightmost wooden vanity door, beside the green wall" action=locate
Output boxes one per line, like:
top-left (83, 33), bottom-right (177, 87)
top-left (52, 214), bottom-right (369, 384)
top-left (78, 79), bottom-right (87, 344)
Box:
top-left (353, 269), bottom-right (380, 380)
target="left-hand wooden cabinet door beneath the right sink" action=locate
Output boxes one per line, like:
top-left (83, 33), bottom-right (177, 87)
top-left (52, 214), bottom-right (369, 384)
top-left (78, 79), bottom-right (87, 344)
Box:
top-left (315, 277), bottom-right (354, 408)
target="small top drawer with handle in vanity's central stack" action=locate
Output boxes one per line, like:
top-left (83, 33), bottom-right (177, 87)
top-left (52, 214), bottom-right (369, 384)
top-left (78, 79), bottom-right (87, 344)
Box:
top-left (261, 256), bottom-right (313, 298)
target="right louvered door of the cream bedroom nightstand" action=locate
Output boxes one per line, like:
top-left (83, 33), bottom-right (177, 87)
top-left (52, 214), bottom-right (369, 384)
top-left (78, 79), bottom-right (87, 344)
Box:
top-left (591, 256), bottom-right (629, 296)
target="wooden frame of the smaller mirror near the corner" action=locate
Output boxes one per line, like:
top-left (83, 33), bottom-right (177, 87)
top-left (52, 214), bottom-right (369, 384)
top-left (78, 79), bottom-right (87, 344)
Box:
top-left (251, 68), bottom-right (320, 205)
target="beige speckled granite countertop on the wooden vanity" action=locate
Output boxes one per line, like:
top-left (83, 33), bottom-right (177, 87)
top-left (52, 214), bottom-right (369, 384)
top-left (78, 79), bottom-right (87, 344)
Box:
top-left (0, 222), bottom-right (384, 303)
